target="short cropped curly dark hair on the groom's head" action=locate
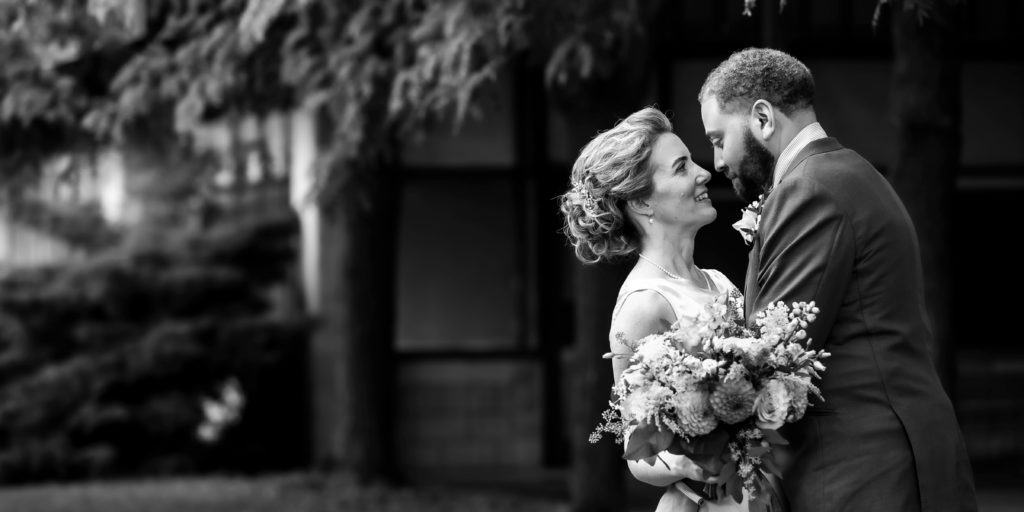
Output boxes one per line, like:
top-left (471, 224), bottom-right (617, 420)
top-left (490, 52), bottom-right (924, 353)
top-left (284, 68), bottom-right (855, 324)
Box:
top-left (697, 48), bottom-right (814, 116)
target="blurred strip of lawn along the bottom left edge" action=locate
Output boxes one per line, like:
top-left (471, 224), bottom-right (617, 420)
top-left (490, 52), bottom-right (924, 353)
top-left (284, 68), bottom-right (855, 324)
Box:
top-left (0, 474), bottom-right (568, 512)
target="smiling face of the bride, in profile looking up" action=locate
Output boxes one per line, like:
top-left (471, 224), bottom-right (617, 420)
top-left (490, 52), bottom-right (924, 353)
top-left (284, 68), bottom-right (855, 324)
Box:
top-left (647, 133), bottom-right (718, 232)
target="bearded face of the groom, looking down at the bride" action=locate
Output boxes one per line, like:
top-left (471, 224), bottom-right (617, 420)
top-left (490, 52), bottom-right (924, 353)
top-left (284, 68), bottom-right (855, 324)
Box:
top-left (700, 98), bottom-right (775, 203)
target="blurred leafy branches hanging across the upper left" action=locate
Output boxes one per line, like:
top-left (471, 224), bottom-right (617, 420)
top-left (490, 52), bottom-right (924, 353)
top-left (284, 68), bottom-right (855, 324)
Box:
top-left (0, 0), bottom-right (659, 196)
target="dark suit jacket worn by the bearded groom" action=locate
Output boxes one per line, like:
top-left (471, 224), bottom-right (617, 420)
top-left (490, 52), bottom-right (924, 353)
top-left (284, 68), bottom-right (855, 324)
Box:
top-left (745, 138), bottom-right (977, 512)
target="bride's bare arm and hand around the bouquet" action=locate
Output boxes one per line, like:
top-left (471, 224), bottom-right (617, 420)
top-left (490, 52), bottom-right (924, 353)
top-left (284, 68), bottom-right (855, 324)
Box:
top-left (608, 290), bottom-right (709, 487)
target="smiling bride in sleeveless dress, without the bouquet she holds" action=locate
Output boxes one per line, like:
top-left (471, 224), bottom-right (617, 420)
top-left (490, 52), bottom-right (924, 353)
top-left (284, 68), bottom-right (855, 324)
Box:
top-left (561, 108), bottom-right (748, 512)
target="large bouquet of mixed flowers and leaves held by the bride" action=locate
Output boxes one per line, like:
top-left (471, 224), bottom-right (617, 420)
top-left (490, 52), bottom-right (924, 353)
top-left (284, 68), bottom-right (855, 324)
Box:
top-left (590, 292), bottom-right (828, 511)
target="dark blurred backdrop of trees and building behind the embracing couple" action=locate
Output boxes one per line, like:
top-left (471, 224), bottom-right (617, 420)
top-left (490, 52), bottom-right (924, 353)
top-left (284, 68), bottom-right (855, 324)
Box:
top-left (0, 0), bottom-right (1024, 512)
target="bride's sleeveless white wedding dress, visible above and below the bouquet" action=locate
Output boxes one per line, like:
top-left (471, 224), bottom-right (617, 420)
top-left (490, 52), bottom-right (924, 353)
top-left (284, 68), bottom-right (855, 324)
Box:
top-left (611, 269), bottom-right (749, 512)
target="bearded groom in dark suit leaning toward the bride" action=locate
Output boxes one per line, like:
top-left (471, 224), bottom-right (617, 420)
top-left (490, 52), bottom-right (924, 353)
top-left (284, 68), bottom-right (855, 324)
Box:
top-left (698, 48), bottom-right (977, 512)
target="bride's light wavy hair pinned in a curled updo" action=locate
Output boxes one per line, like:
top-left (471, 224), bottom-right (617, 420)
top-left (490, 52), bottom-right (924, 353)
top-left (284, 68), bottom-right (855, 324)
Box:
top-left (561, 108), bottom-right (672, 263)
